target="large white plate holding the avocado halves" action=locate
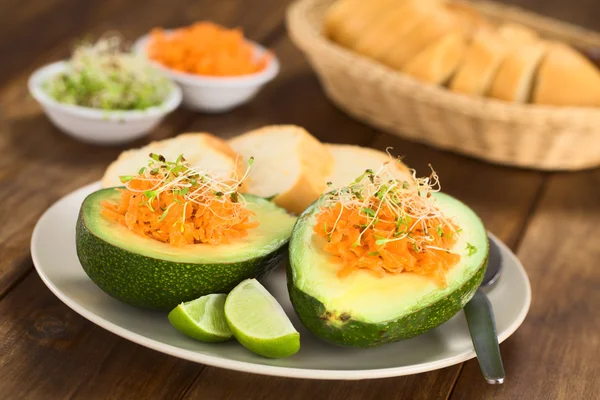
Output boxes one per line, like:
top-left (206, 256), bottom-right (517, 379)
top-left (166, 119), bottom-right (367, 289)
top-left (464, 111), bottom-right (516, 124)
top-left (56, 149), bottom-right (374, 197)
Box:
top-left (31, 183), bottom-right (531, 379)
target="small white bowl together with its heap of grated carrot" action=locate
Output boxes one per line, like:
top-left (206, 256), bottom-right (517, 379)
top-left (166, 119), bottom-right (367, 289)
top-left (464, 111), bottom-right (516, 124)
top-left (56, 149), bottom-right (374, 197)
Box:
top-left (134, 22), bottom-right (279, 113)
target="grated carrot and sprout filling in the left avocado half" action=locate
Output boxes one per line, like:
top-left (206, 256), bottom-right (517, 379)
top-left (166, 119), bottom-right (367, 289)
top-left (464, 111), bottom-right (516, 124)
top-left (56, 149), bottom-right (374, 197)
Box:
top-left (101, 154), bottom-right (258, 247)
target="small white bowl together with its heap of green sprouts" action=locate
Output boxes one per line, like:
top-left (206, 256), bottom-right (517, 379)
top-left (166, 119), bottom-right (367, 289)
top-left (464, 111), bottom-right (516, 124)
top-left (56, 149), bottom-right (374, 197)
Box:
top-left (28, 36), bottom-right (182, 145)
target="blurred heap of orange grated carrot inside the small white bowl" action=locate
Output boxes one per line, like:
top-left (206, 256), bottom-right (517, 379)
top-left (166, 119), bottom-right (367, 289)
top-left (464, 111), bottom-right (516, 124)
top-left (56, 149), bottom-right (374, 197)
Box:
top-left (148, 22), bottom-right (271, 76)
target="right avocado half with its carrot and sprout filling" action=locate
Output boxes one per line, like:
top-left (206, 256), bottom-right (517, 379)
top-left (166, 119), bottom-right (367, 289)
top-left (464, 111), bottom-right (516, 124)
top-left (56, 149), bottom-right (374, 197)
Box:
top-left (288, 162), bottom-right (489, 347)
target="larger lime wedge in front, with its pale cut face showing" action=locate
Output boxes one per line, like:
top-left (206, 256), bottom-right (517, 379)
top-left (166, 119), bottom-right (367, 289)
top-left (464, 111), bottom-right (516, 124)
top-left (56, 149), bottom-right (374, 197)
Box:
top-left (225, 279), bottom-right (300, 358)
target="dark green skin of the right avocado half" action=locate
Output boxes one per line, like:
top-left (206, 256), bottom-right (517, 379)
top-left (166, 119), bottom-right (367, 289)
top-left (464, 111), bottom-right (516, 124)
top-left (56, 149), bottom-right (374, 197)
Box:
top-left (287, 260), bottom-right (487, 347)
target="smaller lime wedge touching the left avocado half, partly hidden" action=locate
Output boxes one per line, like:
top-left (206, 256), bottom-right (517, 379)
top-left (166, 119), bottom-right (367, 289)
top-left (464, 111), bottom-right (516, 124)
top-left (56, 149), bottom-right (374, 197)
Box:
top-left (169, 294), bottom-right (232, 342)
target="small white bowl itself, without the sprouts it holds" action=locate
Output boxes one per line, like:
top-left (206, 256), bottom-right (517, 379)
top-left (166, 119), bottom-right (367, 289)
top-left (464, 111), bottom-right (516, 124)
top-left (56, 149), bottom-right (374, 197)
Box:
top-left (28, 61), bottom-right (181, 145)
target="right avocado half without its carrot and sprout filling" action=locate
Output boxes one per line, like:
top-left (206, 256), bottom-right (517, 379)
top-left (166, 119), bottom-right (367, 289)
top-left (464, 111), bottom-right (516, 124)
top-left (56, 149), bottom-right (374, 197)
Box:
top-left (287, 193), bottom-right (489, 347)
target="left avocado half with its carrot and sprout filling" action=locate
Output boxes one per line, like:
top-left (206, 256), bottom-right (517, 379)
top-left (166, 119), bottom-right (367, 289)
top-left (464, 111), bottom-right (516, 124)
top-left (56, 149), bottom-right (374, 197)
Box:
top-left (76, 154), bottom-right (295, 310)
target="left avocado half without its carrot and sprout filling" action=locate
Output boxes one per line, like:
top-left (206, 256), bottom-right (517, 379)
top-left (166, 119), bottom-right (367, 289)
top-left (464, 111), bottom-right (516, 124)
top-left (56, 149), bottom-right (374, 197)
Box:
top-left (76, 188), bottom-right (296, 310)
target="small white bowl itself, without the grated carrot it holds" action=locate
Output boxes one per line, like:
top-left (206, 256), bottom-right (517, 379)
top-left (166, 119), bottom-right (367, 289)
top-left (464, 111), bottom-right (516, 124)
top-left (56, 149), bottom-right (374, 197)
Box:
top-left (133, 31), bottom-right (279, 113)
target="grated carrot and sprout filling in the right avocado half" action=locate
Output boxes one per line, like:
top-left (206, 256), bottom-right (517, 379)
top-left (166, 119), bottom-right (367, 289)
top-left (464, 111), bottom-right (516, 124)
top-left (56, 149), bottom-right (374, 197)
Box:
top-left (314, 164), bottom-right (460, 286)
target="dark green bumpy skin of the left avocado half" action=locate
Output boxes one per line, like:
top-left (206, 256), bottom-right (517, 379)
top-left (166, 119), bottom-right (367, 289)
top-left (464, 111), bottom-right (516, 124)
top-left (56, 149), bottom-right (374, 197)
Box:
top-left (76, 209), bottom-right (287, 311)
